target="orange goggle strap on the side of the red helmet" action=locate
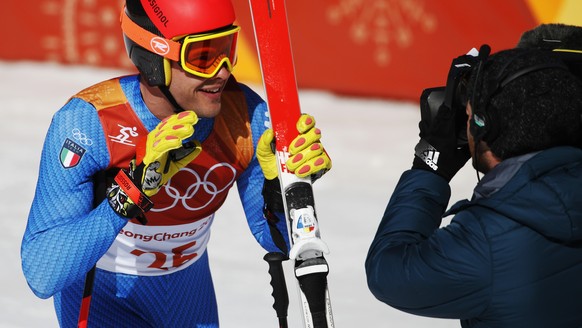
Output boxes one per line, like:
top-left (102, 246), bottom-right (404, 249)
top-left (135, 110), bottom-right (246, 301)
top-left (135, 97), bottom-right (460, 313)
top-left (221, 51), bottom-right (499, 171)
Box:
top-left (120, 6), bottom-right (181, 61)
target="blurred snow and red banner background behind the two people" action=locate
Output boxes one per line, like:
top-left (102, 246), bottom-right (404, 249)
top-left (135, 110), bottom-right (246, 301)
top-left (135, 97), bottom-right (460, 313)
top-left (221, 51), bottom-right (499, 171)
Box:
top-left (0, 0), bottom-right (582, 328)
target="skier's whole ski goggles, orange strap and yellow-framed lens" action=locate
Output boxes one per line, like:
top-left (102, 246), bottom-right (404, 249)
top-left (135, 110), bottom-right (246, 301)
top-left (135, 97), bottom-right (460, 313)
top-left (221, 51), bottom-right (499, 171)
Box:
top-left (121, 10), bottom-right (240, 78)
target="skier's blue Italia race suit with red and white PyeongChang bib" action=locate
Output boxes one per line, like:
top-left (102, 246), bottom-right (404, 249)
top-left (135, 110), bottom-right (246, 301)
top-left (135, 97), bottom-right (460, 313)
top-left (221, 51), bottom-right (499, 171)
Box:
top-left (21, 75), bottom-right (289, 327)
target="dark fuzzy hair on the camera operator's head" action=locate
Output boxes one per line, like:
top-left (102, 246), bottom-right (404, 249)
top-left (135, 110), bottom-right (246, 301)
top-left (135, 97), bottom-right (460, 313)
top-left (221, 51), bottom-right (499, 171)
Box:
top-left (467, 49), bottom-right (582, 160)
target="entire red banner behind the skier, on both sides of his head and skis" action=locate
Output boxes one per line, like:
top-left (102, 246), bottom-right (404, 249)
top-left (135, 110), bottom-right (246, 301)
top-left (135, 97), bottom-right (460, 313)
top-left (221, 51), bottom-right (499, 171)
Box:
top-left (0, 0), bottom-right (537, 100)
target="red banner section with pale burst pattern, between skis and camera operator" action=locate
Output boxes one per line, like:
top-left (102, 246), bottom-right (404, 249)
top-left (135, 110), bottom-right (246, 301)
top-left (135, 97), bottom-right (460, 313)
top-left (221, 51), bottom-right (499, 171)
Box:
top-left (278, 0), bottom-right (536, 100)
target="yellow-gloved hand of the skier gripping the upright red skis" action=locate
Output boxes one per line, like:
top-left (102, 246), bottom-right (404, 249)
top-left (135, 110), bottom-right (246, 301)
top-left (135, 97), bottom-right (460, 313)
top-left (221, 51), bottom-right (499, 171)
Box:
top-left (257, 114), bottom-right (331, 181)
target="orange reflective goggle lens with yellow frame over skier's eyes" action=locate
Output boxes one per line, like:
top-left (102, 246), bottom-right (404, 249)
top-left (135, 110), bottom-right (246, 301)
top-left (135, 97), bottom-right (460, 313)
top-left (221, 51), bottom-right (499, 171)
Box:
top-left (180, 26), bottom-right (240, 78)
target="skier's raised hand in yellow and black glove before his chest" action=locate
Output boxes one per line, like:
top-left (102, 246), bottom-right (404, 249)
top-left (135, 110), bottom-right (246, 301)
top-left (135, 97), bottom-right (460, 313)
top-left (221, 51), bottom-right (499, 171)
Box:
top-left (108, 111), bottom-right (202, 222)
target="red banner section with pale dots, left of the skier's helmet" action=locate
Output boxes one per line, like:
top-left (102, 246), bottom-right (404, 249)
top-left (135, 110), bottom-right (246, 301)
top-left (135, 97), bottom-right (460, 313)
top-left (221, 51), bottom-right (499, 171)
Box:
top-left (0, 0), bottom-right (131, 67)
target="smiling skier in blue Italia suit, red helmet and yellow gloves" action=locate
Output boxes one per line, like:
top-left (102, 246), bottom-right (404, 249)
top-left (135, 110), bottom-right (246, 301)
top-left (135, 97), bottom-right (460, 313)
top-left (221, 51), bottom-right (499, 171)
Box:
top-left (21, 0), bottom-right (331, 327)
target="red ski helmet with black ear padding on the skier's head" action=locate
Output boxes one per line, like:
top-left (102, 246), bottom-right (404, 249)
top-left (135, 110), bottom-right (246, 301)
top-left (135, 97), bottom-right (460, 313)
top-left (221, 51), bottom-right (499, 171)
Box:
top-left (121, 0), bottom-right (236, 86)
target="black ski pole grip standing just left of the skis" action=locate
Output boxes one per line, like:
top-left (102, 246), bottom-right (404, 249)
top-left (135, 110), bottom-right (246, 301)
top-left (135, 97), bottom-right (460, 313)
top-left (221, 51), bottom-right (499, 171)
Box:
top-left (263, 252), bottom-right (289, 328)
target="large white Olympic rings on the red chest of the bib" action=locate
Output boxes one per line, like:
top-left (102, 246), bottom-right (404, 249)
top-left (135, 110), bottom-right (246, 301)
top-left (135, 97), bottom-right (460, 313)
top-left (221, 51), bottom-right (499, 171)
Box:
top-left (150, 163), bottom-right (236, 212)
